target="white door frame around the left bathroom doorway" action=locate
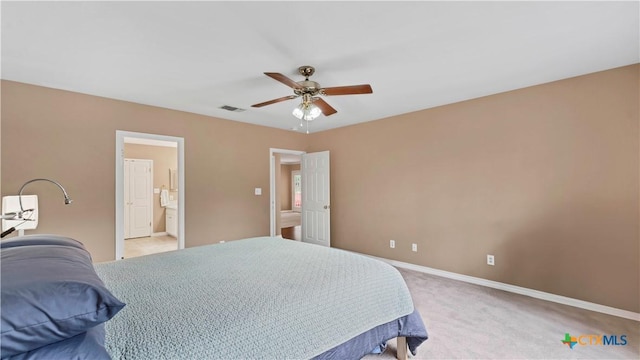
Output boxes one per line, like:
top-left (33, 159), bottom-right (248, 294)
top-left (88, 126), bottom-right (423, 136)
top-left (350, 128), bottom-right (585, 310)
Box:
top-left (115, 130), bottom-right (185, 260)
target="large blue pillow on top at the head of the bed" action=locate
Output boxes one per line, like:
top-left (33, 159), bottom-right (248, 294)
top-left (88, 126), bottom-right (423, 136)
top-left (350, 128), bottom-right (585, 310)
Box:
top-left (0, 239), bottom-right (125, 358)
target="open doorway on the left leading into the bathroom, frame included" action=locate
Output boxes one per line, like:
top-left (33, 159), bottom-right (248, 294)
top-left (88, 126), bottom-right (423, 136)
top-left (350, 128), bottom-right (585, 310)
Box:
top-left (115, 131), bottom-right (185, 259)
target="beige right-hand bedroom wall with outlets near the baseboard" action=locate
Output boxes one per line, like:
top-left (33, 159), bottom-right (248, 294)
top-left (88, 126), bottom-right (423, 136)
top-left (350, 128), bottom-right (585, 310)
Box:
top-left (310, 65), bottom-right (640, 312)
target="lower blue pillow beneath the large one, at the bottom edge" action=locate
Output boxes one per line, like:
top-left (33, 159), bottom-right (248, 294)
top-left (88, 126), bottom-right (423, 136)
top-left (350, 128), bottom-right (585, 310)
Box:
top-left (4, 324), bottom-right (111, 360)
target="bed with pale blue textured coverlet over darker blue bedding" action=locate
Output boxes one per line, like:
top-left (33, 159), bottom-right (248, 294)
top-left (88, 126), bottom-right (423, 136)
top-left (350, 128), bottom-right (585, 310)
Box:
top-left (0, 236), bottom-right (428, 359)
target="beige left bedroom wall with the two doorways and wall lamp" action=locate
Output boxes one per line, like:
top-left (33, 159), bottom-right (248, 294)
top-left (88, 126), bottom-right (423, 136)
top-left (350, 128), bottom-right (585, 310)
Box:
top-left (1, 80), bottom-right (308, 261)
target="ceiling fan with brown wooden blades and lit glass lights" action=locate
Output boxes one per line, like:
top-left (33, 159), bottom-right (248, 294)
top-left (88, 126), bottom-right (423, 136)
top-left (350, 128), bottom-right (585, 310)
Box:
top-left (251, 65), bottom-right (373, 121)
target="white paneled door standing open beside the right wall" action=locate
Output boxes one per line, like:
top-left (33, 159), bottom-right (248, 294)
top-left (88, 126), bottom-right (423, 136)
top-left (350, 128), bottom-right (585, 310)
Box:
top-left (300, 151), bottom-right (331, 246)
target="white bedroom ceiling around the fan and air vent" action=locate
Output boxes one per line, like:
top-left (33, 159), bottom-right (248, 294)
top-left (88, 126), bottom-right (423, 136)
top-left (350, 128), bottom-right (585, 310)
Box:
top-left (1, 1), bottom-right (640, 132)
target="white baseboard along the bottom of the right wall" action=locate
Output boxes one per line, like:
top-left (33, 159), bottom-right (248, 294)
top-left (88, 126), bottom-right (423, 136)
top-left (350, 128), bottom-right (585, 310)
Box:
top-left (363, 254), bottom-right (640, 321)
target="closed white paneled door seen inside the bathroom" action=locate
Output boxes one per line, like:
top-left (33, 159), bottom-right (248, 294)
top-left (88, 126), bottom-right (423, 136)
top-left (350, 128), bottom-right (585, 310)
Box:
top-left (124, 159), bottom-right (153, 239)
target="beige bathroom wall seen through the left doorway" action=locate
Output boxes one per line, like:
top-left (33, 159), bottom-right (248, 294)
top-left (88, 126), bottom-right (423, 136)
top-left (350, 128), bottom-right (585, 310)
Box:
top-left (124, 144), bottom-right (178, 233)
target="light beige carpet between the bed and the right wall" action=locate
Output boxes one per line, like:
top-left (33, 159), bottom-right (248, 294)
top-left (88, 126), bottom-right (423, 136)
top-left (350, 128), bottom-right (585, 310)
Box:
top-left (364, 269), bottom-right (640, 360)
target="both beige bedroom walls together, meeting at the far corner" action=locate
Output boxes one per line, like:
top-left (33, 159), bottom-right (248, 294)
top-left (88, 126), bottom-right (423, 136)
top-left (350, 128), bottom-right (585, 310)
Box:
top-left (1, 65), bottom-right (640, 312)
